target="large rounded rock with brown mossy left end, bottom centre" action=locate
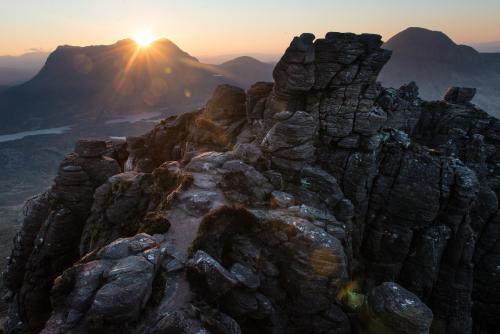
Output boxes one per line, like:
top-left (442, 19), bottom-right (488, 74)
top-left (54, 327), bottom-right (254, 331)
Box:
top-left (189, 207), bottom-right (346, 332)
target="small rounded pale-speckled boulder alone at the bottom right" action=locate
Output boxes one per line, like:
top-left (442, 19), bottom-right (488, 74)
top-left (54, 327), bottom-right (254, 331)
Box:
top-left (363, 282), bottom-right (432, 334)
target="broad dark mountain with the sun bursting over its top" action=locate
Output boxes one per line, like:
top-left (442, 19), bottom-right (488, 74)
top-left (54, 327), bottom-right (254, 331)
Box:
top-left (0, 39), bottom-right (272, 133)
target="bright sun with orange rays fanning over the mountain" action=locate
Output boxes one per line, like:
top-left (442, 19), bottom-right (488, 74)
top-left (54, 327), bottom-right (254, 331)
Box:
top-left (100, 30), bottom-right (221, 110)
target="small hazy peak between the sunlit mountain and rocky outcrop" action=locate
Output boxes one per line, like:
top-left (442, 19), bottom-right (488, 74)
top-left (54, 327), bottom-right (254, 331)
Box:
top-left (219, 56), bottom-right (274, 87)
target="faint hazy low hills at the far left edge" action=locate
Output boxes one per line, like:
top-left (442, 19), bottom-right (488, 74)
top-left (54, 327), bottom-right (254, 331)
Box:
top-left (0, 51), bottom-right (49, 86)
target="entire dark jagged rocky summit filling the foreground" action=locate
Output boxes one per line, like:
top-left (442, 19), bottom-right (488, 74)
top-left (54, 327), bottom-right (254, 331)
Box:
top-left (4, 32), bottom-right (500, 334)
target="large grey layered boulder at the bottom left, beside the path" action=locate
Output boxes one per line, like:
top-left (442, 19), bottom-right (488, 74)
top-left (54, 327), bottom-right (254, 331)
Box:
top-left (43, 234), bottom-right (162, 333)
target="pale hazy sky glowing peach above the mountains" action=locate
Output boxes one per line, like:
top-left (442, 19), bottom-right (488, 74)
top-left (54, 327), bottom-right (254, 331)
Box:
top-left (0, 0), bottom-right (500, 56)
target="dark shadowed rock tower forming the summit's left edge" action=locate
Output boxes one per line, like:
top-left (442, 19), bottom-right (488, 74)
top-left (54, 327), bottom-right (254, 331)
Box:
top-left (4, 144), bottom-right (120, 333)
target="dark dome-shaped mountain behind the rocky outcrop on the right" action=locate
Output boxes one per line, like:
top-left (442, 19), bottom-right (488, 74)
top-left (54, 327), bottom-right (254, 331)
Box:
top-left (379, 28), bottom-right (500, 116)
